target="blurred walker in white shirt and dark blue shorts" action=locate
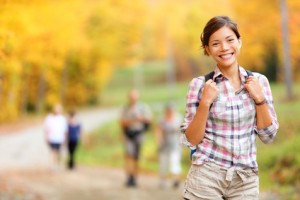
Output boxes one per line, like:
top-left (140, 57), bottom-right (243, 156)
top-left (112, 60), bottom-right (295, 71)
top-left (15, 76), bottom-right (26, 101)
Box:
top-left (44, 104), bottom-right (68, 171)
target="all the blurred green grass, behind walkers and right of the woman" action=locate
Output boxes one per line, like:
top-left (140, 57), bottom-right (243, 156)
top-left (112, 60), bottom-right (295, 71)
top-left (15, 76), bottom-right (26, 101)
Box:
top-left (78, 63), bottom-right (300, 196)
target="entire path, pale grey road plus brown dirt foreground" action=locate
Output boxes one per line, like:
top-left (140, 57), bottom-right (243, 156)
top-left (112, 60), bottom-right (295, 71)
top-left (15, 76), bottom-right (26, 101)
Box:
top-left (0, 109), bottom-right (181, 200)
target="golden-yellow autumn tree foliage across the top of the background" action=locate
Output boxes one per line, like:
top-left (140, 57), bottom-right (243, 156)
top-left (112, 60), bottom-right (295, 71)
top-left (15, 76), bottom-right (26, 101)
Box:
top-left (0, 0), bottom-right (300, 122)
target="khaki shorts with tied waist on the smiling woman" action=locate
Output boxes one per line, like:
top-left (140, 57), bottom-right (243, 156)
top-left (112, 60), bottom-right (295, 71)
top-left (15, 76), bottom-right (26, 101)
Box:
top-left (183, 162), bottom-right (259, 200)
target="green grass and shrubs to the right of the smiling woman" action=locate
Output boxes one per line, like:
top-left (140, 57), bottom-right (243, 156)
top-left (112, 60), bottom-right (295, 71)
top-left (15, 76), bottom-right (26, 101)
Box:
top-left (257, 84), bottom-right (300, 193)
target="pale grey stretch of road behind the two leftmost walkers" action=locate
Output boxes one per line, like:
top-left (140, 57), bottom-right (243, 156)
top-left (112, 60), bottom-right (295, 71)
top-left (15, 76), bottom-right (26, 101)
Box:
top-left (0, 109), bottom-right (119, 171)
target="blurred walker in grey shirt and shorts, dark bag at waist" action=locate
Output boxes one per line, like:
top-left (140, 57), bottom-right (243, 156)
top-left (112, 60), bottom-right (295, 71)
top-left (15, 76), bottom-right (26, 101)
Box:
top-left (121, 89), bottom-right (151, 187)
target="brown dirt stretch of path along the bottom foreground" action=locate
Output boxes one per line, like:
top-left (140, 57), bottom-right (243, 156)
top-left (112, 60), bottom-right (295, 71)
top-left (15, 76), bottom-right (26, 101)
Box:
top-left (0, 167), bottom-right (181, 200)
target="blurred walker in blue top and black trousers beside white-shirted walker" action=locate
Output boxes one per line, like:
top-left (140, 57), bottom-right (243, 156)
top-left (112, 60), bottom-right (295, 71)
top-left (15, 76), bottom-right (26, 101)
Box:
top-left (67, 110), bottom-right (81, 170)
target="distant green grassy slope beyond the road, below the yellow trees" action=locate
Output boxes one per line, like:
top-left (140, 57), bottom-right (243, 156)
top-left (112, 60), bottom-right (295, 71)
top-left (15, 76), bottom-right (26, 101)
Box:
top-left (100, 62), bottom-right (188, 106)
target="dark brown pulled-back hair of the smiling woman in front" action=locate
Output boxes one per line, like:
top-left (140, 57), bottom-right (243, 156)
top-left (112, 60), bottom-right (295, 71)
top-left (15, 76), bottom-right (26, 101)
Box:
top-left (200, 16), bottom-right (241, 56)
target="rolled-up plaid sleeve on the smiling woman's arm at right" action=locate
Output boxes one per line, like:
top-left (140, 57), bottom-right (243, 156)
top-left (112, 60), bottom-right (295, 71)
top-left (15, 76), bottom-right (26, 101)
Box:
top-left (255, 75), bottom-right (279, 144)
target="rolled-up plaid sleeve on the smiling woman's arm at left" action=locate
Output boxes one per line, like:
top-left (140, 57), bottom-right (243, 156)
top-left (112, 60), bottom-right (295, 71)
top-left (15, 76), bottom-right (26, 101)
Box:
top-left (180, 76), bottom-right (204, 149)
